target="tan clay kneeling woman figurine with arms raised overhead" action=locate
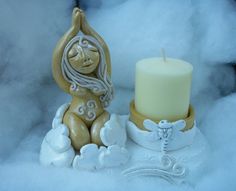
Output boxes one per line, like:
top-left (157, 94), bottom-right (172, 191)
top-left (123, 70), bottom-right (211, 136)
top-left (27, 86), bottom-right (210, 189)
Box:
top-left (52, 8), bottom-right (113, 150)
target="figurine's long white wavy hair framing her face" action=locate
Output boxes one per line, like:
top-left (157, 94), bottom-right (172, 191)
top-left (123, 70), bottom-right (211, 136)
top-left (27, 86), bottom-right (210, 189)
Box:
top-left (61, 35), bottom-right (113, 107)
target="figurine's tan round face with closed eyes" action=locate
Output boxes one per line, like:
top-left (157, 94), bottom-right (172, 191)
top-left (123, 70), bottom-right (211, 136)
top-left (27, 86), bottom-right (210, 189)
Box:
top-left (67, 41), bottom-right (99, 74)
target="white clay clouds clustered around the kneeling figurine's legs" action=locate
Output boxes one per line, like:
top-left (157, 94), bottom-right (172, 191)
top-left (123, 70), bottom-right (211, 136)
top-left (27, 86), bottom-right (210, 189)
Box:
top-left (40, 104), bottom-right (129, 170)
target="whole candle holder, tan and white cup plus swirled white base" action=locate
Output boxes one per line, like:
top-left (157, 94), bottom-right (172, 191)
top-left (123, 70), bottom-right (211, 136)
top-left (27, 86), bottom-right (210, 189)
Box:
top-left (123, 101), bottom-right (208, 184)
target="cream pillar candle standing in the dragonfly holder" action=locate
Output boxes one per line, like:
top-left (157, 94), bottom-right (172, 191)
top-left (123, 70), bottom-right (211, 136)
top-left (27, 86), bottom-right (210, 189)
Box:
top-left (135, 58), bottom-right (193, 121)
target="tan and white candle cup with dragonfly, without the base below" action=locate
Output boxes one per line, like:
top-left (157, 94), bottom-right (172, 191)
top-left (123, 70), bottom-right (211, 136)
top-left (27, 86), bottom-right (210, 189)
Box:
top-left (127, 101), bottom-right (196, 151)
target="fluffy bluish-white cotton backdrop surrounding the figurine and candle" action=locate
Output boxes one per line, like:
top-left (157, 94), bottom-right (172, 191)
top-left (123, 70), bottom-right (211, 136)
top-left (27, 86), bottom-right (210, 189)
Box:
top-left (0, 0), bottom-right (236, 191)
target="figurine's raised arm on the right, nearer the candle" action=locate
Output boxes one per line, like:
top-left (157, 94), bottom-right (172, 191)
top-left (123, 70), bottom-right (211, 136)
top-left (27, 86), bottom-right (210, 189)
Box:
top-left (81, 12), bottom-right (111, 76)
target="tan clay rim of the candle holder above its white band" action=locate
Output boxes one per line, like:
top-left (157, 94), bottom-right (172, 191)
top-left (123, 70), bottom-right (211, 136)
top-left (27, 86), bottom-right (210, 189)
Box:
top-left (129, 100), bottom-right (195, 132)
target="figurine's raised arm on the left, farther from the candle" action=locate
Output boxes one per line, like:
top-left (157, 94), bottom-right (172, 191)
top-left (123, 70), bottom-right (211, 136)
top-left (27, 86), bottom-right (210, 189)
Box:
top-left (52, 8), bottom-right (81, 93)
